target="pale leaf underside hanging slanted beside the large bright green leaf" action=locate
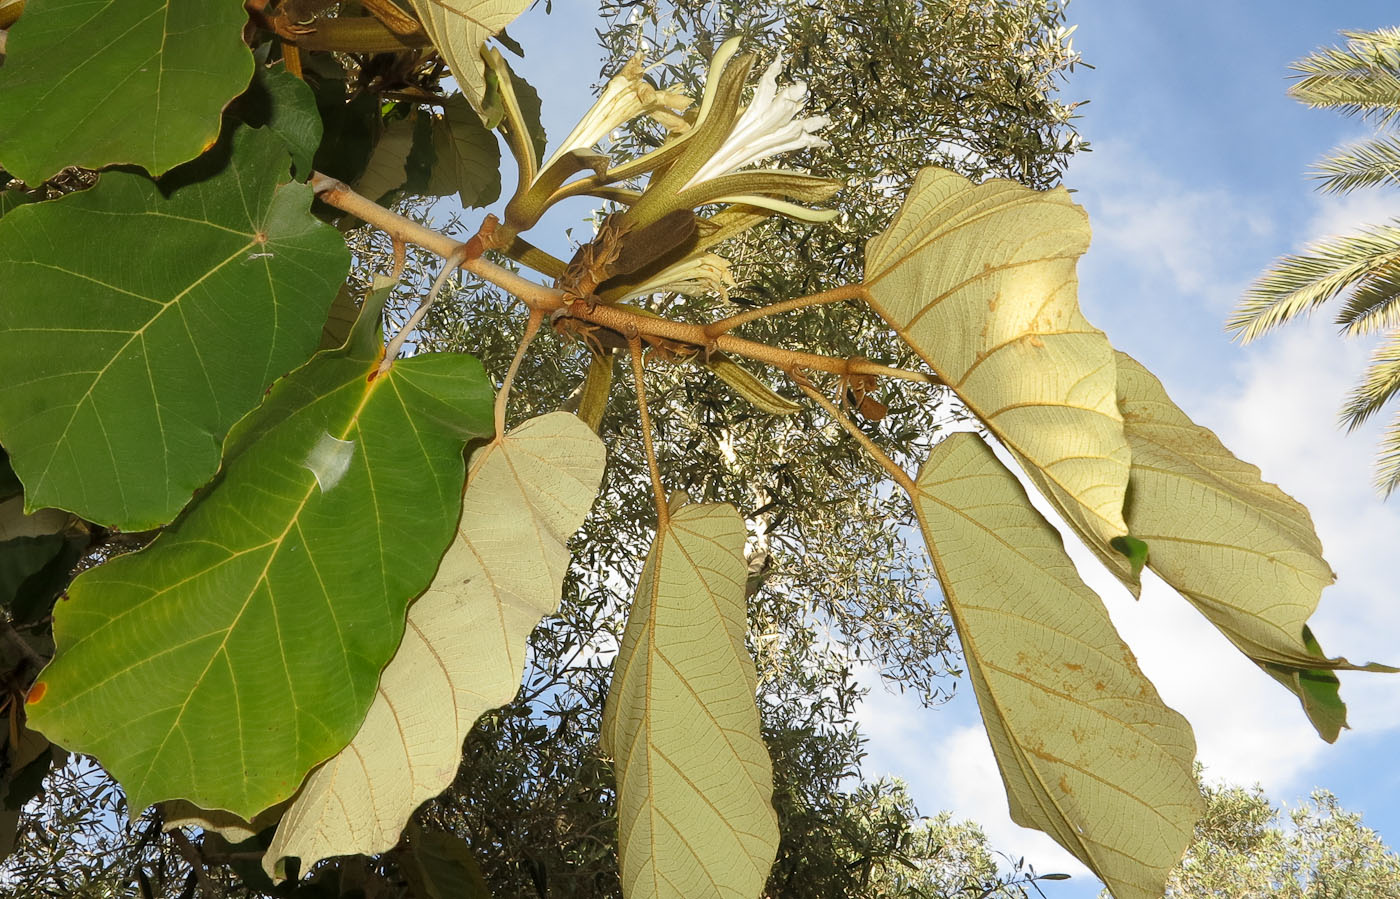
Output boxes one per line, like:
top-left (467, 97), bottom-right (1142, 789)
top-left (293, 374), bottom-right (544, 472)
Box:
top-left (263, 412), bottom-right (605, 877)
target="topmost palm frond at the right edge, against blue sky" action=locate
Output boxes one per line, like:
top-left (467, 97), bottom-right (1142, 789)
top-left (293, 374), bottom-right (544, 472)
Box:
top-left (1288, 28), bottom-right (1400, 125)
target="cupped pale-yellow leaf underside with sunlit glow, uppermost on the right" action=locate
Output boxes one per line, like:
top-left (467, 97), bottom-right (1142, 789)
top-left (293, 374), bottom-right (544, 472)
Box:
top-left (865, 168), bottom-right (1130, 567)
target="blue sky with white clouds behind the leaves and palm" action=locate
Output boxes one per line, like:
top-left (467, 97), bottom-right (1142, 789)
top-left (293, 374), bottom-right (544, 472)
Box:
top-left (495, 0), bottom-right (1400, 899)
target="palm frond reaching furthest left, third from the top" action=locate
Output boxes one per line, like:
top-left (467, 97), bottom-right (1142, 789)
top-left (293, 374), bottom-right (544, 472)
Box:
top-left (1225, 218), bottom-right (1400, 343)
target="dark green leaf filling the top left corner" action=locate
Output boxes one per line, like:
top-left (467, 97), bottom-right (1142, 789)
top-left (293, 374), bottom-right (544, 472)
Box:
top-left (0, 0), bottom-right (253, 185)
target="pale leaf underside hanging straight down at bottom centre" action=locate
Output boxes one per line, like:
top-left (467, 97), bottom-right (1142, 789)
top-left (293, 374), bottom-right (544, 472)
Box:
top-left (602, 493), bottom-right (778, 899)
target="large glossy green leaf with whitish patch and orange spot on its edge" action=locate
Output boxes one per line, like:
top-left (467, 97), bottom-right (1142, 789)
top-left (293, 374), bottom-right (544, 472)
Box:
top-left (29, 296), bottom-right (491, 819)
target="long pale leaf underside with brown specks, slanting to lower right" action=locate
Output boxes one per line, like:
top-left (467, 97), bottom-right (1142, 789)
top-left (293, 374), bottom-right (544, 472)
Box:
top-left (913, 434), bottom-right (1201, 899)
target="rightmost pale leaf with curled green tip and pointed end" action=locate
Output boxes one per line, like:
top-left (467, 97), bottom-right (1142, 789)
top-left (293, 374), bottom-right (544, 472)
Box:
top-left (1117, 353), bottom-right (1393, 742)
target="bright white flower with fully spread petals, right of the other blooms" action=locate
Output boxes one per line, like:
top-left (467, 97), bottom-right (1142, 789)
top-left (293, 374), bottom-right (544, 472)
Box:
top-left (682, 57), bottom-right (830, 190)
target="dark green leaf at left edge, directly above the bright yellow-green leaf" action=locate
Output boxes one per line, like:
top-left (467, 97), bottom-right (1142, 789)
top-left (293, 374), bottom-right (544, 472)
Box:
top-left (0, 129), bottom-right (350, 531)
